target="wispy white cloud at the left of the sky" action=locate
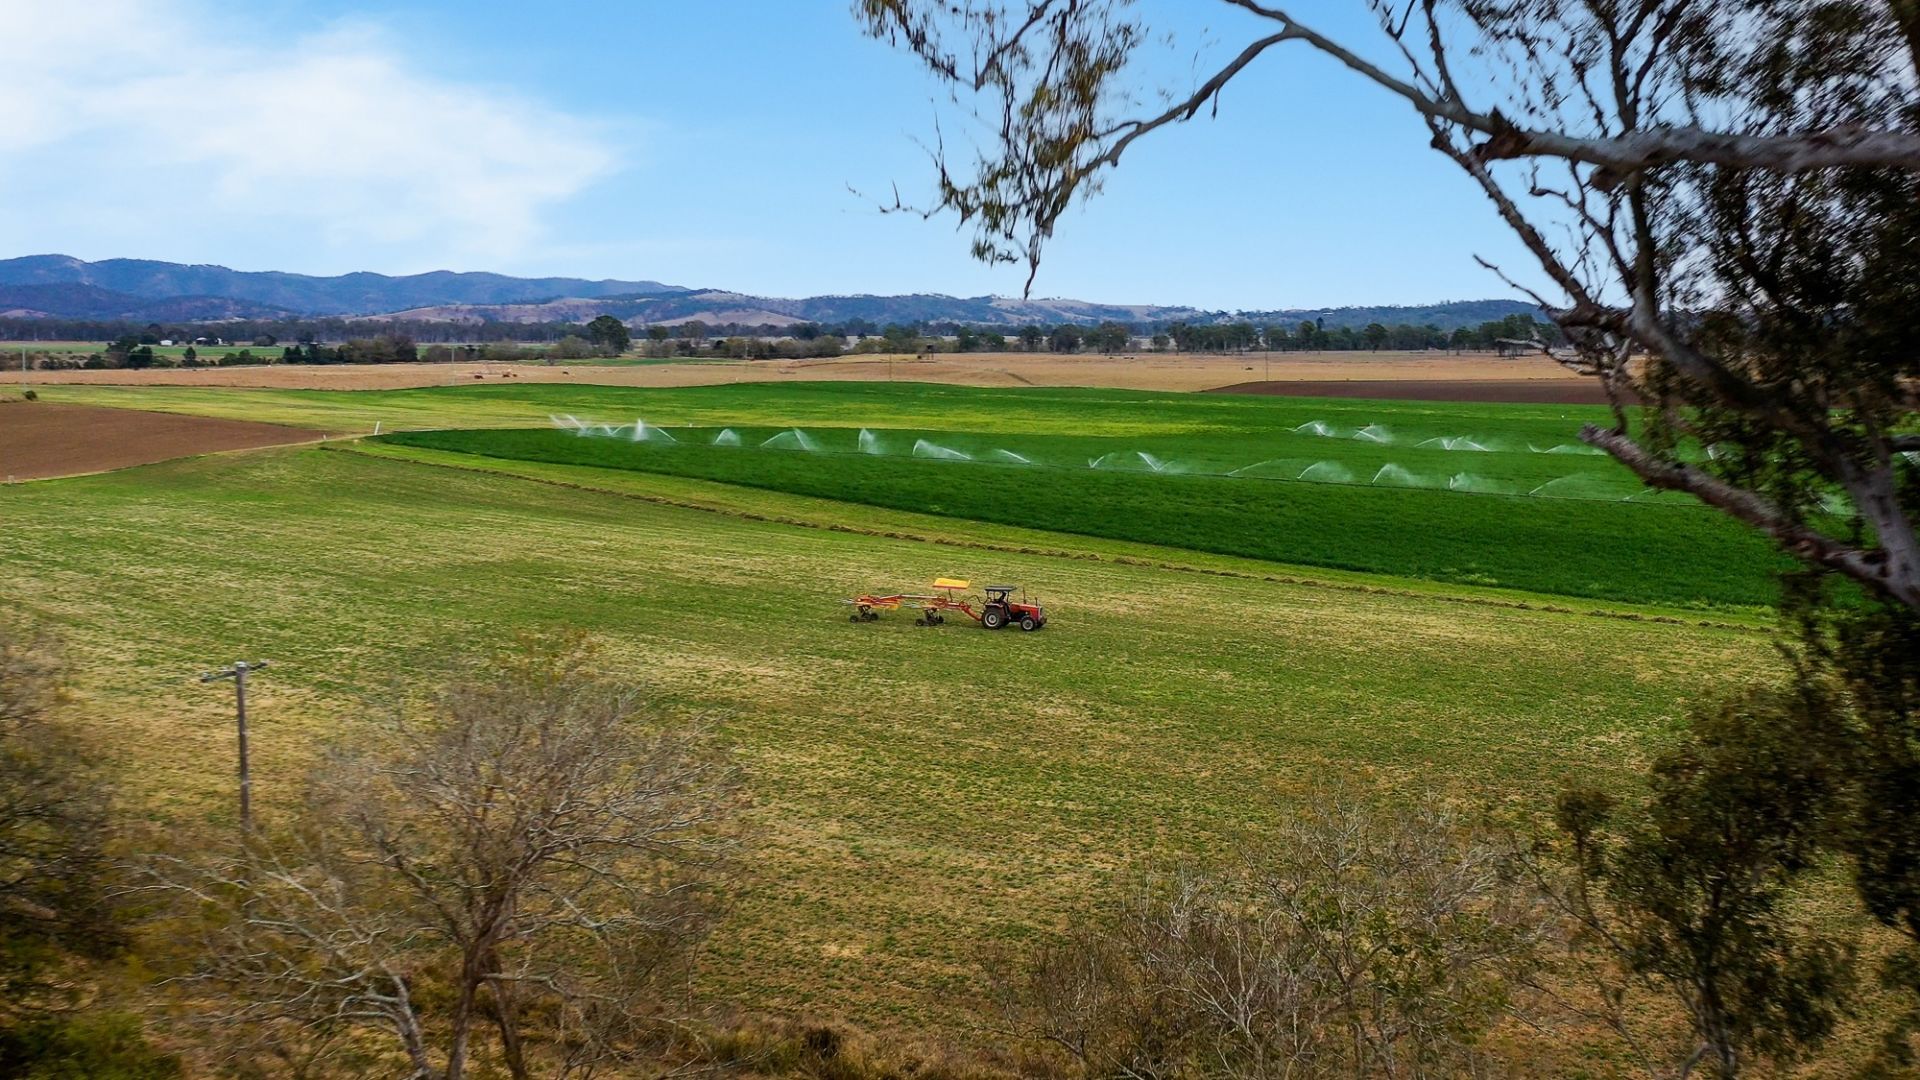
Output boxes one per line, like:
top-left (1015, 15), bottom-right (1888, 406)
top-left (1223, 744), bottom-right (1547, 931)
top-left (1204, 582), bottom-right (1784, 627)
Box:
top-left (0, 0), bottom-right (616, 269)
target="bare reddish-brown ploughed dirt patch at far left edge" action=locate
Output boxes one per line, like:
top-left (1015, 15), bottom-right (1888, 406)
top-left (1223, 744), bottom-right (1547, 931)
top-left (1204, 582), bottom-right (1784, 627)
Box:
top-left (0, 402), bottom-right (321, 482)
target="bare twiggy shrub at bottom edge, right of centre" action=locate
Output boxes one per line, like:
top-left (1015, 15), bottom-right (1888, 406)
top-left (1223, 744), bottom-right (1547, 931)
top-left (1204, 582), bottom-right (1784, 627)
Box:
top-left (998, 799), bottom-right (1553, 1078)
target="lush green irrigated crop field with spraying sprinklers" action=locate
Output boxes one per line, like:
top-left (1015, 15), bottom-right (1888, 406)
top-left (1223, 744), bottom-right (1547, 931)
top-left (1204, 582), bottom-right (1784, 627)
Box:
top-left (33, 382), bottom-right (1786, 611)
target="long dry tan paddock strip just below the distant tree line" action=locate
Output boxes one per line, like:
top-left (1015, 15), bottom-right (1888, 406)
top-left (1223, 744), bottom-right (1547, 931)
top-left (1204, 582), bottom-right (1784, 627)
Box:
top-left (31, 352), bottom-right (1586, 400)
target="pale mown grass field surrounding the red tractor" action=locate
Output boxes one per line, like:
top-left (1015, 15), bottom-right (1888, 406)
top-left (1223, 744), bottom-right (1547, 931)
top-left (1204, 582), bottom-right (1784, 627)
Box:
top-left (0, 440), bottom-right (1772, 1038)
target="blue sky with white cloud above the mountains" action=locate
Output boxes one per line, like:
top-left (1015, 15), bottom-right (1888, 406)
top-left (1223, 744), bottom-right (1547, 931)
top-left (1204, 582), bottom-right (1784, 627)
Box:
top-left (0, 0), bottom-right (1523, 307)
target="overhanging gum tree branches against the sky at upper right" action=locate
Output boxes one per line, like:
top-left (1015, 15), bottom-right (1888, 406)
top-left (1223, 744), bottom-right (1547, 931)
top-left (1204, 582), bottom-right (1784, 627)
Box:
top-left (854, 0), bottom-right (1920, 609)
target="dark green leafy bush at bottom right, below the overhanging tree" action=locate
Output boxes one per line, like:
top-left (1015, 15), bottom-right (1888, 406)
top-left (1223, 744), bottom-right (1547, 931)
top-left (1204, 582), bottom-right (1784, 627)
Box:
top-left (1534, 684), bottom-right (1857, 1078)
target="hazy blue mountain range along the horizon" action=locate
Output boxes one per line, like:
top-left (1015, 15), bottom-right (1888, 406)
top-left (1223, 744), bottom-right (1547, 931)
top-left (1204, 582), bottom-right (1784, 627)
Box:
top-left (0, 256), bottom-right (1538, 331)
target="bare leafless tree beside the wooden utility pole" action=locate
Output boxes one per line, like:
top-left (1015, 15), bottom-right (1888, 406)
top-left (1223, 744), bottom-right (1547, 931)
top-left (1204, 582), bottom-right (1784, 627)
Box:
top-left (150, 638), bottom-right (737, 1080)
